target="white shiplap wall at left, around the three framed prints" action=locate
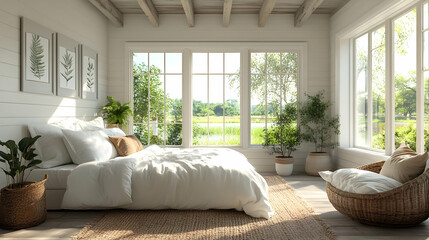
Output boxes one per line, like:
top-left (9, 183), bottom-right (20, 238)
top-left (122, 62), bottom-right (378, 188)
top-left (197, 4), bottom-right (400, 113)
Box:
top-left (0, 0), bottom-right (108, 186)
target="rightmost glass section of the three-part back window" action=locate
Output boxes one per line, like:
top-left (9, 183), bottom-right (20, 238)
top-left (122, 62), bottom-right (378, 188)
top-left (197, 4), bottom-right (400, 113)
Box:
top-left (250, 52), bottom-right (298, 144)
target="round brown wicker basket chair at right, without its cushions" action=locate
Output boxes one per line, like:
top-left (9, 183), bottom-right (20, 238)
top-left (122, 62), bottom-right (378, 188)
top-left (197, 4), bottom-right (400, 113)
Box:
top-left (326, 161), bottom-right (429, 227)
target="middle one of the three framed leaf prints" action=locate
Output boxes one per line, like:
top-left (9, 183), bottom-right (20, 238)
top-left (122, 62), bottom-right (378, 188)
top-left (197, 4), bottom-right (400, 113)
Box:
top-left (55, 33), bottom-right (80, 97)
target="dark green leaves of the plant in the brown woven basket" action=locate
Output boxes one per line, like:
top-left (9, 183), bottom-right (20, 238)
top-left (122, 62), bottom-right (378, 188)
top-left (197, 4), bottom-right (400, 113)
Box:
top-left (0, 136), bottom-right (42, 188)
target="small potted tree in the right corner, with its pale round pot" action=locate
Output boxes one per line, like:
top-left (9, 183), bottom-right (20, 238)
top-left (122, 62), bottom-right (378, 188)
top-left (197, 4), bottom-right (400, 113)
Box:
top-left (300, 91), bottom-right (340, 176)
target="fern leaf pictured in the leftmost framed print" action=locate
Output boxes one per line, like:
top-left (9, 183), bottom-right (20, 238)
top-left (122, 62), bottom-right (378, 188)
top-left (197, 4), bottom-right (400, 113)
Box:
top-left (30, 34), bottom-right (45, 80)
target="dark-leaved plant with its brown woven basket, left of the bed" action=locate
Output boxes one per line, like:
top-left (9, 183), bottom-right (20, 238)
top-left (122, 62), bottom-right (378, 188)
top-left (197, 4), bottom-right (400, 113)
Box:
top-left (0, 136), bottom-right (48, 229)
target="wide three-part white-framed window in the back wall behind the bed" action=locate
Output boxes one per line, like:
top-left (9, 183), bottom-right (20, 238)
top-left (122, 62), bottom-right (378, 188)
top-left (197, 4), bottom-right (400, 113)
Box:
top-left (127, 43), bottom-right (307, 148)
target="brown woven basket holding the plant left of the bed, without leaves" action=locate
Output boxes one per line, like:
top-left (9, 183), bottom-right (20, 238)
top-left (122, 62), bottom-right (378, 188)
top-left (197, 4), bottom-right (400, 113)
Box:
top-left (0, 175), bottom-right (48, 229)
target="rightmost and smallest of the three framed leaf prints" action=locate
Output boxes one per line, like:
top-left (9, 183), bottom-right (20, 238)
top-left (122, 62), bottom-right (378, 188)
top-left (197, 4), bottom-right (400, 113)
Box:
top-left (80, 45), bottom-right (98, 100)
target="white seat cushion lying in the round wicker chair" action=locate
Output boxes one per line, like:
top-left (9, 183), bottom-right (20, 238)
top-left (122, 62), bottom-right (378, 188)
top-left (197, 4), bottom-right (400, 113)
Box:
top-left (319, 168), bottom-right (402, 194)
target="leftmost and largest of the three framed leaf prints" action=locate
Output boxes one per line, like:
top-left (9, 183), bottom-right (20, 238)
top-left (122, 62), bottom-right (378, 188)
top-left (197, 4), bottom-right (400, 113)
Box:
top-left (20, 17), bottom-right (56, 95)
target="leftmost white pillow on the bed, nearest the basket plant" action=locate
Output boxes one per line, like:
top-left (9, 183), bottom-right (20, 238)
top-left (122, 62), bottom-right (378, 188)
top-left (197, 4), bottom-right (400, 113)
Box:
top-left (28, 124), bottom-right (72, 168)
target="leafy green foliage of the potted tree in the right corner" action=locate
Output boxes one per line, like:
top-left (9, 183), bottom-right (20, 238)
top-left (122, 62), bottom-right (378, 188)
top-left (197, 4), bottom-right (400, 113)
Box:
top-left (300, 92), bottom-right (340, 152)
